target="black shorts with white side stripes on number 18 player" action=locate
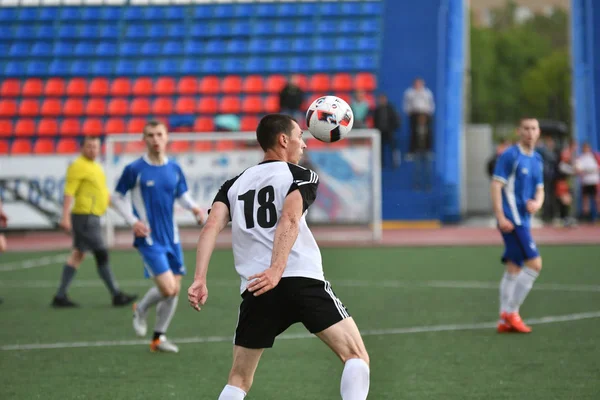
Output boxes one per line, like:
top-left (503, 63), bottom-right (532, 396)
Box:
top-left (234, 277), bottom-right (350, 349)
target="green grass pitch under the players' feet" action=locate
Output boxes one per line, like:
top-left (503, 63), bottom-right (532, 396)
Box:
top-left (0, 246), bottom-right (600, 400)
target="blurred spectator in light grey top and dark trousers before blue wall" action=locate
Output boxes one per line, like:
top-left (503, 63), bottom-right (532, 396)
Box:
top-left (404, 78), bottom-right (435, 153)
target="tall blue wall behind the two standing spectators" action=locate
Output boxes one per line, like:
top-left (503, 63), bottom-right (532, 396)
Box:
top-left (379, 0), bottom-right (465, 221)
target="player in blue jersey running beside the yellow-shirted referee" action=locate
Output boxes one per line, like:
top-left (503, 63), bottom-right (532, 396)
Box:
top-left (112, 121), bottom-right (204, 353)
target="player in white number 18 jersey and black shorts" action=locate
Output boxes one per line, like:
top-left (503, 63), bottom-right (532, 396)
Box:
top-left (188, 114), bottom-right (369, 400)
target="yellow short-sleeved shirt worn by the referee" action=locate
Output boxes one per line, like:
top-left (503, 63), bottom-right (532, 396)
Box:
top-left (65, 156), bottom-right (109, 216)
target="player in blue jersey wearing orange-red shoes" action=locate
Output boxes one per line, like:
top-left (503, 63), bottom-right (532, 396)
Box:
top-left (490, 118), bottom-right (544, 333)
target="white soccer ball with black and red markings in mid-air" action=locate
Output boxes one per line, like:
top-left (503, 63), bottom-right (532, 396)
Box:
top-left (306, 96), bottom-right (354, 143)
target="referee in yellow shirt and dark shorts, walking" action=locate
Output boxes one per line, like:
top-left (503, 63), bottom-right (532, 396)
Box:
top-left (52, 136), bottom-right (137, 308)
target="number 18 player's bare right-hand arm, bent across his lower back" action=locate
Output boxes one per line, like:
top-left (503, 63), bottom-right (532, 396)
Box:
top-left (248, 190), bottom-right (303, 296)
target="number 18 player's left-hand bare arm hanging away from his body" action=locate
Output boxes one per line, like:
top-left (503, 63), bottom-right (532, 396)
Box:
top-left (188, 201), bottom-right (229, 311)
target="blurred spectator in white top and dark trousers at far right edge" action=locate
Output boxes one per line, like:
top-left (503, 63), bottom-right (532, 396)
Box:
top-left (575, 143), bottom-right (600, 222)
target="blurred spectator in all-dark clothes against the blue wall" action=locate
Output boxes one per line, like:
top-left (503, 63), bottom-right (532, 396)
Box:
top-left (373, 94), bottom-right (400, 168)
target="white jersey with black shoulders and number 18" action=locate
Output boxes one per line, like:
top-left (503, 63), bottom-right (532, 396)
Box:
top-left (213, 161), bottom-right (325, 293)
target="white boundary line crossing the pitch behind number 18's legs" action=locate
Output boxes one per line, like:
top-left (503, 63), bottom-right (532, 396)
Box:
top-left (0, 311), bottom-right (600, 351)
